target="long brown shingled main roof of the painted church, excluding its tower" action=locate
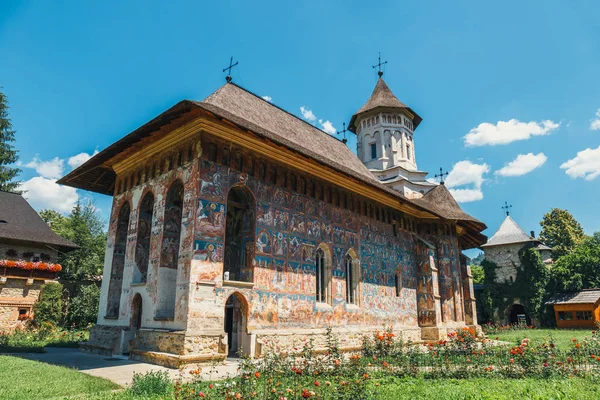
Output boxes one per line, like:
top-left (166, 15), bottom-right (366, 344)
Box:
top-left (58, 83), bottom-right (485, 247)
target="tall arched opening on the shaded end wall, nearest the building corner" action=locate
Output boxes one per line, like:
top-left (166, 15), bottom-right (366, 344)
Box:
top-left (156, 180), bottom-right (184, 319)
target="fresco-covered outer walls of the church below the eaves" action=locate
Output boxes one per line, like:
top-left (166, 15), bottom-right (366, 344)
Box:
top-left (90, 134), bottom-right (469, 365)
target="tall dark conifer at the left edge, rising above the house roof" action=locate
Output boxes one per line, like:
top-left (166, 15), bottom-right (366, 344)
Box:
top-left (0, 92), bottom-right (21, 192)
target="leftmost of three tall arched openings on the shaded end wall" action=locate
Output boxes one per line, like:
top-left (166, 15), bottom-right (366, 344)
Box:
top-left (105, 203), bottom-right (130, 318)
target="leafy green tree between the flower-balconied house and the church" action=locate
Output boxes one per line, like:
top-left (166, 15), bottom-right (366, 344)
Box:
top-left (40, 201), bottom-right (106, 279)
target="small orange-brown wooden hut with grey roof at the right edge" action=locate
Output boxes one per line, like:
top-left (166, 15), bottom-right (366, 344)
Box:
top-left (546, 289), bottom-right (600, 328)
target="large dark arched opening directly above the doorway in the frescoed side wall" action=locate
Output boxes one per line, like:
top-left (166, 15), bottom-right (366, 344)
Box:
top-left (223, 186), bottom-right (254, 282)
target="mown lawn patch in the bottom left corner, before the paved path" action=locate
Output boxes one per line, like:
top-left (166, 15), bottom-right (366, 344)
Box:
top-left (0, 356), bottom-right (120, 400)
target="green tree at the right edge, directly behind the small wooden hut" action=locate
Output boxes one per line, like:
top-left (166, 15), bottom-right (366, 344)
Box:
top-left (549, 232), bottom-right (600, 292)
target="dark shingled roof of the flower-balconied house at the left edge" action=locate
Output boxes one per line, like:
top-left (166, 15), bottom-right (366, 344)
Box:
top-left (0, 191), bottom-right (79, 251)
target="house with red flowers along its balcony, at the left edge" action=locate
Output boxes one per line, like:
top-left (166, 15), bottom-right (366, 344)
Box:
top-left (0, 191), bottom-right (78, 330)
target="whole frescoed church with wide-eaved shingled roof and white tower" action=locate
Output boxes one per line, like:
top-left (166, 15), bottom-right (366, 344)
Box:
top-left (59, 75), bottom-right (486, 366)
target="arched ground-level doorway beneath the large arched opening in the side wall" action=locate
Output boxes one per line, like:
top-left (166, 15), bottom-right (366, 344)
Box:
top-left (225, 293), bottom-right (250, 357)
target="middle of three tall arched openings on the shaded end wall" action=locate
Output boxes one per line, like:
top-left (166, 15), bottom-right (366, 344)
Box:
top-left (133, 192), bottom-right (154, 283)
